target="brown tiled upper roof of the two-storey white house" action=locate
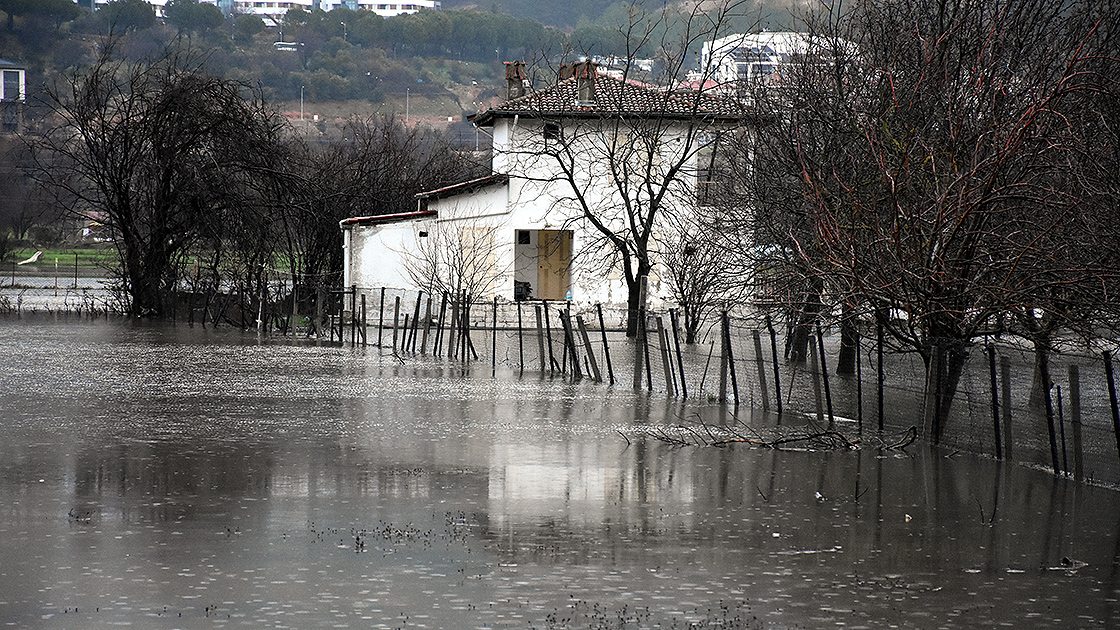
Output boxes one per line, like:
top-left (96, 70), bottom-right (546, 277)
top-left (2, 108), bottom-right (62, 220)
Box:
top-left (474, 74), bottom-right (748, 127)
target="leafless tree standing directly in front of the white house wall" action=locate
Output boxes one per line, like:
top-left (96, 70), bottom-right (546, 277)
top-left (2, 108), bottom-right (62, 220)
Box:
top-left (477, 2), bottom-right (747, 335)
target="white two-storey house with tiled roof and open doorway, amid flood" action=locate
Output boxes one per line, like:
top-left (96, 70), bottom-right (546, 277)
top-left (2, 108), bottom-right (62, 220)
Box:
top-left (340, 62), bottom-right (745, 306)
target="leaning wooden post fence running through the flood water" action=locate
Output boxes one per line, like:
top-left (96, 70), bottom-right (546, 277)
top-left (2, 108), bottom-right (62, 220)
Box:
top-left (0, 278), bottom-right (1120, 485)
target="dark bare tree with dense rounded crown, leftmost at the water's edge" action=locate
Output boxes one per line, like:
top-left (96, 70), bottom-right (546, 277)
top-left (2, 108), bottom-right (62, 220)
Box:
top-left (36, 39), bottom-right (280, 315)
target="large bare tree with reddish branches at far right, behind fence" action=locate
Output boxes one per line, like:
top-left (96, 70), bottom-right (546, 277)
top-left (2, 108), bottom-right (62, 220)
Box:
top-left (734, 0), bottom-right (1120, 438)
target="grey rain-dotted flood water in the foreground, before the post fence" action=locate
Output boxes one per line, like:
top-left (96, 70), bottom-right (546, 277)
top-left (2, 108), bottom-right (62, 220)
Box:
top-left (0, 318), bottom-right (1120, 629)
